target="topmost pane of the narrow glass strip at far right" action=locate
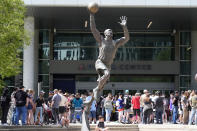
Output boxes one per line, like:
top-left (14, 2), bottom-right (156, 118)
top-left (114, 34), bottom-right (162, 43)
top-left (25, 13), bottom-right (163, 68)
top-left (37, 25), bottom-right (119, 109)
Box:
top-left (180, 32), bottom-right (191, 45)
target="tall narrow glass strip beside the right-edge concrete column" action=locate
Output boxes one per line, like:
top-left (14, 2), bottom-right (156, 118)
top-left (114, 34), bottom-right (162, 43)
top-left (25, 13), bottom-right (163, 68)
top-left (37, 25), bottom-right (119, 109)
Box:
top-left (179, 32), bottom-right (191, 90)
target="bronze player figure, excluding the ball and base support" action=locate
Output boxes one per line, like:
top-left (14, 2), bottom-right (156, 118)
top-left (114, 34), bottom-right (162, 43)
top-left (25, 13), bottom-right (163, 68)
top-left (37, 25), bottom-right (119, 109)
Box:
top-left (90, 13), bottom-right (129, 100)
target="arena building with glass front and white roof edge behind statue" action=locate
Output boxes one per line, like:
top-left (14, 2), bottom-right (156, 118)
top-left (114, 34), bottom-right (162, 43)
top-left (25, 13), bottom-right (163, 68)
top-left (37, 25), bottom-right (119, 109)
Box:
top-left (10, 0), bottom-right (197, 94)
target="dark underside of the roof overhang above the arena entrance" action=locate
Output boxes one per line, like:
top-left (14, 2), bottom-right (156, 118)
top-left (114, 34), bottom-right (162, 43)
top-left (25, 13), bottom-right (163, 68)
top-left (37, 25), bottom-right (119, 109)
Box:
top-left (27, 7), bottom-right (197, 32)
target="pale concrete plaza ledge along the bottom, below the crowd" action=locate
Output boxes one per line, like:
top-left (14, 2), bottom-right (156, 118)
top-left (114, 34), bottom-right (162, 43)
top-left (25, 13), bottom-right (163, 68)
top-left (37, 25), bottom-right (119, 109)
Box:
top-left (0, 122), bottom-right (197, 131)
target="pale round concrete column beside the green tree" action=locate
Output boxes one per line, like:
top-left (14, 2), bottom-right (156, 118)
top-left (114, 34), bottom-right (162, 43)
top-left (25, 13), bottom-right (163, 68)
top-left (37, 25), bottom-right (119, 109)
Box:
top-left (23, 16), bottom-right (38, 91)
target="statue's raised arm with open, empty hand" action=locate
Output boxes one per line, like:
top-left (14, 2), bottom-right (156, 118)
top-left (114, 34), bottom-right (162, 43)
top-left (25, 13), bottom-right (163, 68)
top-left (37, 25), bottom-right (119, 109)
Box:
top-left (116, 16), bottom-right (129, 46)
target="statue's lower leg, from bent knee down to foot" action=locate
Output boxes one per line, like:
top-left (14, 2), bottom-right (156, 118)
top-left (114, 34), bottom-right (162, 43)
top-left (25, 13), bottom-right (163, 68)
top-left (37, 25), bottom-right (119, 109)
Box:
top-left (93, 69), bottom-right (110, 101)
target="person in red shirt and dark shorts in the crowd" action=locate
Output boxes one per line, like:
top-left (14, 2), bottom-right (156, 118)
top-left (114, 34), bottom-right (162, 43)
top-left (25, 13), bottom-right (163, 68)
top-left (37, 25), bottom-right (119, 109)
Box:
top-left (131, 93), bottom-right (141, 123)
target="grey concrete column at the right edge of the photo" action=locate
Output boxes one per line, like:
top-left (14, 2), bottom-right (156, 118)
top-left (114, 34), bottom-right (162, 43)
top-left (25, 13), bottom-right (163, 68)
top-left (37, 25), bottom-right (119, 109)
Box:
top-left (191, 31), bottom-right (197, 89)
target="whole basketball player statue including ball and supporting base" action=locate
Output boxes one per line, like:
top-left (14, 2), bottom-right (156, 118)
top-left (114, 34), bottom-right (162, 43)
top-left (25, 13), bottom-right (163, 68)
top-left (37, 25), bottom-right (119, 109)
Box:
top-left (81, 3), bottom-right (129, 131)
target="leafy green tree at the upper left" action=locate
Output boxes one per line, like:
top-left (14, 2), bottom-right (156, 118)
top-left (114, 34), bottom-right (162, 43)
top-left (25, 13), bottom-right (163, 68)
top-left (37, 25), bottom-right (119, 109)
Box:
top-left (0, 0), bottom-right (28, 89)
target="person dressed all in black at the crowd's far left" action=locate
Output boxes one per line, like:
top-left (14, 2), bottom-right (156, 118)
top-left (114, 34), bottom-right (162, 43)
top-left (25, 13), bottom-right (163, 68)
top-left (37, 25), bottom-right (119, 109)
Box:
top-left (1, 87), bottom-right (11, 125)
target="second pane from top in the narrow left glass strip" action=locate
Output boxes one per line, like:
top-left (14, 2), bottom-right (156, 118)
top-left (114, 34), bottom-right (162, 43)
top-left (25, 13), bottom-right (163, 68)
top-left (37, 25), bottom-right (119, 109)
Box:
top-left (39, 44), bottom-right (50, 59)
